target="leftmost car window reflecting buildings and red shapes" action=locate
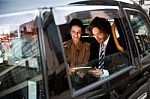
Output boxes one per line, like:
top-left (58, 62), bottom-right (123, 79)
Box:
top-left (0, 11), bottom-right (44, 99)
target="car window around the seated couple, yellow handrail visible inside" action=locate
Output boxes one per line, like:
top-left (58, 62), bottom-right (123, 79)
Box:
top-left (54, 8), bottom-right (131, 97)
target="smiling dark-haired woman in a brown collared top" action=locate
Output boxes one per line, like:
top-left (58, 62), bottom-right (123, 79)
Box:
top-left (64, 19), bottom-right (90, 77)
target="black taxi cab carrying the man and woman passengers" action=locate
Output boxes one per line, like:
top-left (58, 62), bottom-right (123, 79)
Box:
top-left (0, 0), bottom-right (150, 99)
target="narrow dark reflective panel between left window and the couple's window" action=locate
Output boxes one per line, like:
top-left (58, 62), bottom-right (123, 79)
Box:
top-left (42, 9), bottom-right (68, 98)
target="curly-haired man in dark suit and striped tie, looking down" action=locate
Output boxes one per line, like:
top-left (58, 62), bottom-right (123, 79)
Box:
top-left (89, 17), bottom-right (118, 77)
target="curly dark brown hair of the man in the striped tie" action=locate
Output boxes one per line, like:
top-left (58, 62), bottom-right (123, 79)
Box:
top-left (88, 17), bottom-right (111, 34)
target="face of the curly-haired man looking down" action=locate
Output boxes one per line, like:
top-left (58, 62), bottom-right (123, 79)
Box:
top-left (92, 27), bottom-right (108, 43)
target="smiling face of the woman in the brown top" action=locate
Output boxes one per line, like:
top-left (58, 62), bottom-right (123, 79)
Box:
top-left (70, 25), bottom-right (81, 43)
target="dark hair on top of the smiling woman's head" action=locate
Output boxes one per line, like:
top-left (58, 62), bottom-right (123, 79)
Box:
top-left (69, 18), bottom-right (83, 31)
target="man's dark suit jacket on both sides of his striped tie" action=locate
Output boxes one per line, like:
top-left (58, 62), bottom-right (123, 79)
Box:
top-left (89, 35), bottom-right (119, 68)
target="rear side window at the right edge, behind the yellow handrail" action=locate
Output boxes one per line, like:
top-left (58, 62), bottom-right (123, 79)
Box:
top-left (127, 10), bottom-right (150, 57)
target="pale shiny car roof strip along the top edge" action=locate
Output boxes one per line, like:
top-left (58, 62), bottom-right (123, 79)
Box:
top-left (0, 0), bottom-right (133, 14)
